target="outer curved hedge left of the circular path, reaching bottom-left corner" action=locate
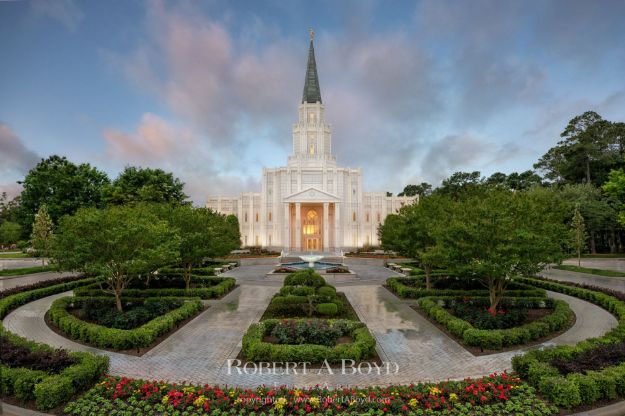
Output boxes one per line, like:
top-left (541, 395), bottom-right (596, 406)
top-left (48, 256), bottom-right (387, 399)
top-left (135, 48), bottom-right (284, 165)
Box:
top-left (0, 278), bottom-right (109, 411)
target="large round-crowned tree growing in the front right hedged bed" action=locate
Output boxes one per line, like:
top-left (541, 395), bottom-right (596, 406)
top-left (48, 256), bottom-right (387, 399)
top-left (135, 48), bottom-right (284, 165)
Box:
top-left (433, 188), bottom-right (569, 309)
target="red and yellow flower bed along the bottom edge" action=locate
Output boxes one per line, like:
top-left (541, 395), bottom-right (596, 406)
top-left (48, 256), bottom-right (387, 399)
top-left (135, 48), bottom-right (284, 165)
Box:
top-left (64, 374), bottom-right (558, 416)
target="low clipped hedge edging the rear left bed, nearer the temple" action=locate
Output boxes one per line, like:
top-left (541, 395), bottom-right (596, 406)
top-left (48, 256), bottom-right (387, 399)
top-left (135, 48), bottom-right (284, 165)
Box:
top-left (74, 276), bottom-right (236, 299)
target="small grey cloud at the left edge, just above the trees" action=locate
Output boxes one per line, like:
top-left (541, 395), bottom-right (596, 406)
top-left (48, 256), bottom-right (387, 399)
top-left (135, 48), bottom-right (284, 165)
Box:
top-left (0, 123), bottom-right (39, 176)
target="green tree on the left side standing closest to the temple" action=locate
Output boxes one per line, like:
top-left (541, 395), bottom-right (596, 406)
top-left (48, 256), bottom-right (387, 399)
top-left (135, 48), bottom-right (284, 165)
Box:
top-left (158, 205), bottom-right (241, 290)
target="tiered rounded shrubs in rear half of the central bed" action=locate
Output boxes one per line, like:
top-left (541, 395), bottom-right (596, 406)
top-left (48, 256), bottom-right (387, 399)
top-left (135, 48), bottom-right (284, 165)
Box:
top-left (261, 269), bottom-right (358, 320)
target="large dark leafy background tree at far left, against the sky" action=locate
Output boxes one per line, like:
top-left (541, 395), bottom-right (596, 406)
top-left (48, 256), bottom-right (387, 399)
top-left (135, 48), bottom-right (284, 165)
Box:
top-left (19, 155), bottom-right (109, 232)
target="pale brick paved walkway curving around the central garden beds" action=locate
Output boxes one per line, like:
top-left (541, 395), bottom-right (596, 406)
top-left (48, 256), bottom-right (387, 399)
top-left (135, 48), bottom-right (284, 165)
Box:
top-left (4, 268), bottom-right (616, 387)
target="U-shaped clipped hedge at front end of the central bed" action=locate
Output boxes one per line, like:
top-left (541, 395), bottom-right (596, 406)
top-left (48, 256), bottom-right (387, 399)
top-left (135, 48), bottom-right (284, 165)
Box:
top-left (242, 319), bottom-right (375, 363)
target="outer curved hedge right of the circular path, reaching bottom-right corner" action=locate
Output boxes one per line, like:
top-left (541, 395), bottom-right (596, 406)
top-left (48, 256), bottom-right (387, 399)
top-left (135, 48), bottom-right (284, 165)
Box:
top-left (512, 277), bottom-right (625, 408)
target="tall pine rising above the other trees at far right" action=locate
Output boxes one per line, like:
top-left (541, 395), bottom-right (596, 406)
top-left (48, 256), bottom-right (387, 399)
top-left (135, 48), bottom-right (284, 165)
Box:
top-left (534, 111), bottom-right (617, 186)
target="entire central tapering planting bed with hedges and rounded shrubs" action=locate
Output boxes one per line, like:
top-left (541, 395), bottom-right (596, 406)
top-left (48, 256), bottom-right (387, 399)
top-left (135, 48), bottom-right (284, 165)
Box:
top-left (239, 269), bottom-right (380, 366)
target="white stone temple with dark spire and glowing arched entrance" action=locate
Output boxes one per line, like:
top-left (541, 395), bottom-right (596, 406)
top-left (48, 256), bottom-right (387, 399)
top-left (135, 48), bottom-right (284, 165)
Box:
top-left (206, 31), bottom-right (417, 253)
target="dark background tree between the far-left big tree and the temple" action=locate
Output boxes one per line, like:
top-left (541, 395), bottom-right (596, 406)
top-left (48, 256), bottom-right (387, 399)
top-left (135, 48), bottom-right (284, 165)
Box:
top-left (105, 166), bottom-right (188, 205)
